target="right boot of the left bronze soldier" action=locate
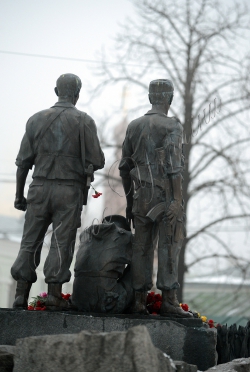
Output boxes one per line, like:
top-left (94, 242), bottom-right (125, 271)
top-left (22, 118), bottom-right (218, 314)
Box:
top-left (45, 283), bottom-right (71, 311)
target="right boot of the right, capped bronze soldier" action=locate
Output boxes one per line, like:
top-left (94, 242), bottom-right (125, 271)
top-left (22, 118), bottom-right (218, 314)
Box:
top-left (160, 289), bottom-right (193, 318)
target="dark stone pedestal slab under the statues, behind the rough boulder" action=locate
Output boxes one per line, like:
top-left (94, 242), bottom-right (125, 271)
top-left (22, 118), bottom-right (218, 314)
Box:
top-left (0, 309), bottom-right (216, 371)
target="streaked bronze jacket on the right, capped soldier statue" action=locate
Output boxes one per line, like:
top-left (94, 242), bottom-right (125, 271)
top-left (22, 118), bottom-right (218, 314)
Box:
top-left (119, 110), bottom-right (183, 183)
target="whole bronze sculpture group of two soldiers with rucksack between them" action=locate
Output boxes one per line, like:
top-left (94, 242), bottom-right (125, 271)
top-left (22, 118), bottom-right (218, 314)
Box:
top-left (11, 74), bottom-right (193, 318)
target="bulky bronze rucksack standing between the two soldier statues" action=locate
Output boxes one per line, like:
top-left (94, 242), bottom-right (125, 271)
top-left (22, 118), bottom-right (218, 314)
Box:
top-left (71, 215), bottom-right (133, 314)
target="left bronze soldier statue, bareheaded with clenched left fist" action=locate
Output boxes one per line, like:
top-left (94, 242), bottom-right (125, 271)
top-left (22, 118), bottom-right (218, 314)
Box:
top-left (11, 74), bottom-right (104, 310)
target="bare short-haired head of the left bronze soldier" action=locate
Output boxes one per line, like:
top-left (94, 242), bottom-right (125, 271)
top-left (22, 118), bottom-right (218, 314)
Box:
top-left (55, 74), bottom-right (82, 98)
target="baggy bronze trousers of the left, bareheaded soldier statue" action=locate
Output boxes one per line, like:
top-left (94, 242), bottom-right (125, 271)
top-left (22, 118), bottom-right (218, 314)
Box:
top-left (11, 178), bottom-right (83, 283)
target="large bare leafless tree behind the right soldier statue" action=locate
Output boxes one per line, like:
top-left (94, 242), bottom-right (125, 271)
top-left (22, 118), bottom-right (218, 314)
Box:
top-left (94, 0), bottom-right (250, 299)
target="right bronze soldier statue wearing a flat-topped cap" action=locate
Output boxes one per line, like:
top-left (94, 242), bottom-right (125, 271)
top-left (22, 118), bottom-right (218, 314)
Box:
top-left (119, 79), bottom-right (192, 317)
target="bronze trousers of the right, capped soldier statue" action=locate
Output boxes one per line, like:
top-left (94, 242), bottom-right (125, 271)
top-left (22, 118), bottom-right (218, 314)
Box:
top-left (131, 186), bottom-right (183, 291)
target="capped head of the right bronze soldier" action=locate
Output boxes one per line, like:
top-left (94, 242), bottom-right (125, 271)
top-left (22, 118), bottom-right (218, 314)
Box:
top-left (148, 79), bottom-right (174, 105)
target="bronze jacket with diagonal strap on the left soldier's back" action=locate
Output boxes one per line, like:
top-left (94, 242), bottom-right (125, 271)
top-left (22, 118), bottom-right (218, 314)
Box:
top-left (16, 102), bottom-right (104, 182)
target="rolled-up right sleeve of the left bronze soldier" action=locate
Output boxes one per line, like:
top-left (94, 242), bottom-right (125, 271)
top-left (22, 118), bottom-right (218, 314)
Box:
top-left (81, 114), bottom-right (105, 170)
